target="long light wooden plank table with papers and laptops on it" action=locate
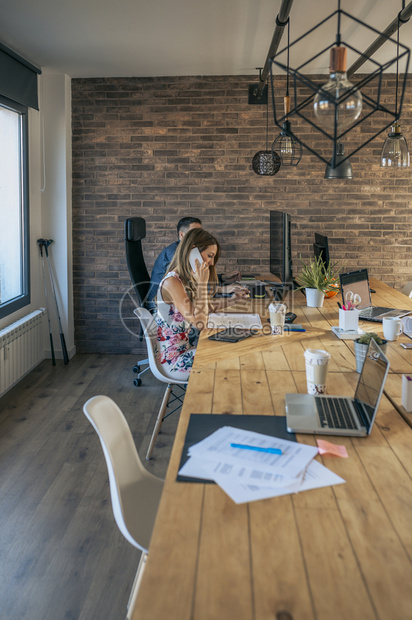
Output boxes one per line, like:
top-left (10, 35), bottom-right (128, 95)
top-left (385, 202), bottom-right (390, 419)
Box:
top-left (132, 280), bottom-right (412, 620)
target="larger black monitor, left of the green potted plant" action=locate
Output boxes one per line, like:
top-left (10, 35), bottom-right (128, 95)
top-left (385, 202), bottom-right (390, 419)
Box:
top-left (270, 211), bottom-right (293, 283)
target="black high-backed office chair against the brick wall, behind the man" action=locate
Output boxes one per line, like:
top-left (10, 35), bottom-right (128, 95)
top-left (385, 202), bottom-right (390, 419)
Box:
top-left (124, 217), bottom-right (150, 386)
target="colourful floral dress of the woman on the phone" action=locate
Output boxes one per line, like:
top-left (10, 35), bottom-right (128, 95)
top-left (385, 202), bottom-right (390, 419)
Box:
top-left (155, 271), bottom-right (196, 373)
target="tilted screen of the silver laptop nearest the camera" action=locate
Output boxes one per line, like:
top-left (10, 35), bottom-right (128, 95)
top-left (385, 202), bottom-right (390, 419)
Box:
top-left (355, 340), bottom-right (389, 432)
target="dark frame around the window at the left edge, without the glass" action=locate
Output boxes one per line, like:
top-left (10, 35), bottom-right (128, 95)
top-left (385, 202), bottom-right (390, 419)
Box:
top-left (0, 95), bottom-right (31, 319)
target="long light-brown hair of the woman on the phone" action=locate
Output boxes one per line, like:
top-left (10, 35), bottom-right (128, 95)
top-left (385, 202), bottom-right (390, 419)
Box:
top-left (167, 228), bottom-right (220, 301)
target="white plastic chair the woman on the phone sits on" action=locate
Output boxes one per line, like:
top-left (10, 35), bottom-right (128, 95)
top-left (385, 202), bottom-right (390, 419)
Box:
top-left (133, 308), bottom-right (190, 460)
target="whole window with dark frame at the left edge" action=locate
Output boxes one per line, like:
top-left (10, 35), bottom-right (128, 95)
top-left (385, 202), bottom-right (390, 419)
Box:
top-left (0, 97), bottom-right (30, 318)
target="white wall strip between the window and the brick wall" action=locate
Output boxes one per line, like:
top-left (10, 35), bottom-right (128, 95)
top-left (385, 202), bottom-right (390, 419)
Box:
top-left (0, 71), bottom-right (75, 358)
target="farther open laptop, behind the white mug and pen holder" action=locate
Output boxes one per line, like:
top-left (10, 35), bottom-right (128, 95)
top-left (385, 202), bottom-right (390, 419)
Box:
top-left (340, 269), bottom-right (411, 323)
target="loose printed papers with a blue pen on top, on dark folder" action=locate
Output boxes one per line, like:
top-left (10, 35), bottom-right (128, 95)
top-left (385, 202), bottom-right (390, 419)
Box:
top-left (179, 426), bottom-right (345, 504)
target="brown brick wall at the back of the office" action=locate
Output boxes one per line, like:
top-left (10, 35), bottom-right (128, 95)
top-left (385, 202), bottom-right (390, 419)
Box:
top-left (72, 76), bottom-right (412, 353)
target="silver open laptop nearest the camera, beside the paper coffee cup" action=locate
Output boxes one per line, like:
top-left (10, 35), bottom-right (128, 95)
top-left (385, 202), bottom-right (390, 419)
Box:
top-left (285, 340), bottom-right (389, 437)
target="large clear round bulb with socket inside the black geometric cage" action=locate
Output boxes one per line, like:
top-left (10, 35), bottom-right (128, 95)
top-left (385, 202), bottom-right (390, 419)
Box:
top-left (313, 46), bottom-right (362, 129)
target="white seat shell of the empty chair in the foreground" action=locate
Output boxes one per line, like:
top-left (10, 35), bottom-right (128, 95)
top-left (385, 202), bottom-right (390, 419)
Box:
top-left (83, 396), bottom-right (163, 552)
